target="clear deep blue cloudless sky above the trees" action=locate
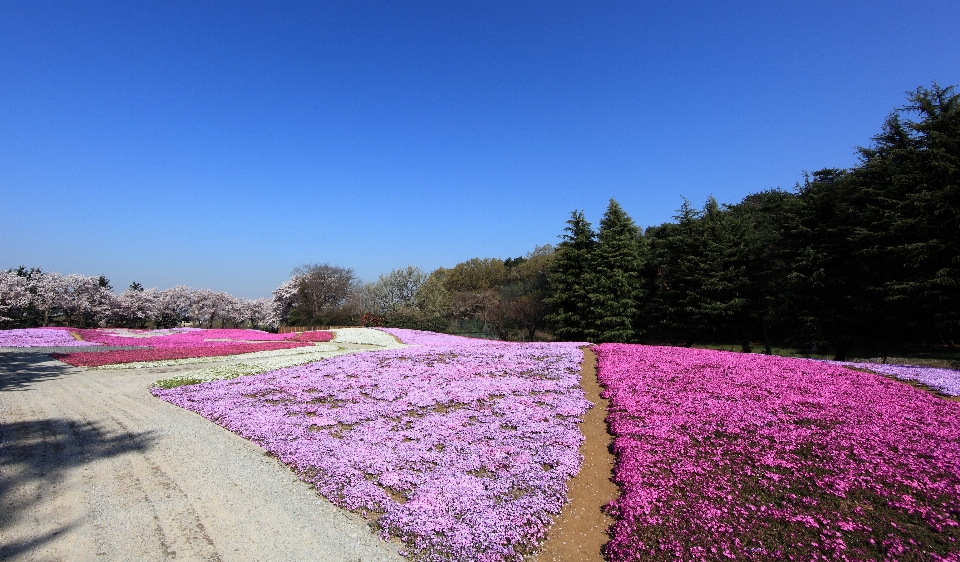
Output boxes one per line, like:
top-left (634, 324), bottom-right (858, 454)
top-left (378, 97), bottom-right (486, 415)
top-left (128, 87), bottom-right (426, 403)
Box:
top-left (0, 0), bottom-right (960, 297)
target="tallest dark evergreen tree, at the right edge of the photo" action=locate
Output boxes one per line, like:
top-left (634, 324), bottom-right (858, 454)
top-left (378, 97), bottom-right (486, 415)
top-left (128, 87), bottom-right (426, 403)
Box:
top-left (851, 83), bottom-right (960, 347)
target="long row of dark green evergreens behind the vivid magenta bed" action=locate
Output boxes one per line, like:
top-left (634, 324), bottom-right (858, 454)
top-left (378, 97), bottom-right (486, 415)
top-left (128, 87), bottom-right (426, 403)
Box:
top-left (547, 84), bottom-right (960, 359)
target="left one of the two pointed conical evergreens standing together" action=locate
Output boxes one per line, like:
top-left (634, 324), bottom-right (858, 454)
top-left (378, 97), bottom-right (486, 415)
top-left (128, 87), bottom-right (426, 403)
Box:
top-left (546, 211), bottom-right (597, 341)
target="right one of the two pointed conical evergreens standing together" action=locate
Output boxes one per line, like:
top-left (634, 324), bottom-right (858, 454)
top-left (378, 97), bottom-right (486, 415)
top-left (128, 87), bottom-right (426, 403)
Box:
top-left (588, 199), bottom-right (647, 342)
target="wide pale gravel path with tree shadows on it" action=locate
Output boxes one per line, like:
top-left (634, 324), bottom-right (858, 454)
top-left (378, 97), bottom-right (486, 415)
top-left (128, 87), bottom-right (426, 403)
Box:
top-left (0, 350), bottom-right (403, 562)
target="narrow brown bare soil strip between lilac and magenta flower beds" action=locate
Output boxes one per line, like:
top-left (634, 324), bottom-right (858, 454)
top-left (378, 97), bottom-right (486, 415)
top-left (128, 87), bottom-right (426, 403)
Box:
top-left (535, 348), bottom-right (619, 562)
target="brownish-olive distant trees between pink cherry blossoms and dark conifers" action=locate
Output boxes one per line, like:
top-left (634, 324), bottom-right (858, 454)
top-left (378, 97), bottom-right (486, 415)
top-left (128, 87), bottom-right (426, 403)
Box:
top-left (273, 246), bottom-right (553, 339)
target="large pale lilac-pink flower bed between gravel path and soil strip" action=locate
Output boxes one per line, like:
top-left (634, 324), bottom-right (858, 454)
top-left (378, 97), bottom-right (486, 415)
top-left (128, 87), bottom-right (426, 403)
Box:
top-left (152, 330), bottom-right (590, 561)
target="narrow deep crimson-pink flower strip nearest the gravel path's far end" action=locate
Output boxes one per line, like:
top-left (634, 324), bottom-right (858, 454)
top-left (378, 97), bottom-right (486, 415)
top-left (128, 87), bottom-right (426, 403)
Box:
top-left (50, 342), bottom-right (310, 367)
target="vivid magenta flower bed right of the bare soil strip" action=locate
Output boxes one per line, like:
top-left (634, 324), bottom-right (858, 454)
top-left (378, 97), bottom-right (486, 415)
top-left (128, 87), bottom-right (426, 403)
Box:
top-left (596, 344), bottom-right (960, 561)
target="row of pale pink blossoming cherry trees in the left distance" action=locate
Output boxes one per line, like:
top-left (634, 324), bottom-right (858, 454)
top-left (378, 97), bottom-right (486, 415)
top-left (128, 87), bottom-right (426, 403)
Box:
top-left (0, 267), bottom-right (278, 328)
